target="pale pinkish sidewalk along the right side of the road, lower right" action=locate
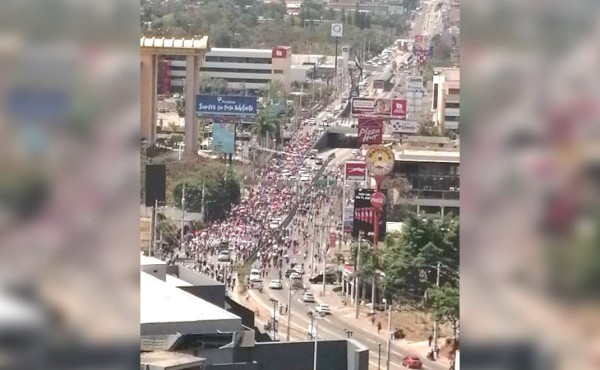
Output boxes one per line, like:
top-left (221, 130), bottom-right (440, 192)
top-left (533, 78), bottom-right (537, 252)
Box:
top-left (310, 284), bottom-right (451, 367)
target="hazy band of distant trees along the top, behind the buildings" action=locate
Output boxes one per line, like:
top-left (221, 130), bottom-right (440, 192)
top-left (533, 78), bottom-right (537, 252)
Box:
top-left (141, 0), bottom-right (416, 55)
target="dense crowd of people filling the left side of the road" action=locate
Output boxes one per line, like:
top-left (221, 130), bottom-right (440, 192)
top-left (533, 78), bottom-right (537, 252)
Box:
top-left (157, 120), bottom-right (342, 286)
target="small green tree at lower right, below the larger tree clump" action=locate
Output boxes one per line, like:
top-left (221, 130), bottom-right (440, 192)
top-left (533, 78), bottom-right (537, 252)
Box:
top-left (427, 284), bottom-right (460, 339)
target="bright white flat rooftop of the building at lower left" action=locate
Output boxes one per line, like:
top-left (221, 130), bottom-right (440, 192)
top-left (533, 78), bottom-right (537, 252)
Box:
top-left (140, 272), bottom-right (240, 326)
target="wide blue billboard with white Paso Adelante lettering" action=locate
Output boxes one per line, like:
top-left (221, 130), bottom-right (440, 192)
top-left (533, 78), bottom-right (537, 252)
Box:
top-left (196, 94), bottom-right (256, 116)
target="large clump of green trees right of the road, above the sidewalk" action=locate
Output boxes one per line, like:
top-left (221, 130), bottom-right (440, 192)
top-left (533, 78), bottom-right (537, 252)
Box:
top-left (353, 213), bottom-right (460, 334)
